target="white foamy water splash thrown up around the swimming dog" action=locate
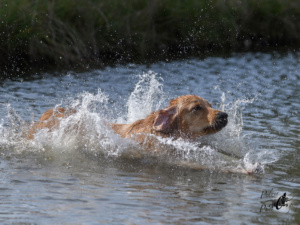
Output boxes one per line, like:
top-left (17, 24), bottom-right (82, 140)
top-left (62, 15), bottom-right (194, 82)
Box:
top-left (0, 71), bottom-right (278, 171)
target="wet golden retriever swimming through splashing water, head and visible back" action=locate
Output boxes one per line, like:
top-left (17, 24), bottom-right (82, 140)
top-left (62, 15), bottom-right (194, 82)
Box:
top-left (26, 95), bottom-right (228, 145)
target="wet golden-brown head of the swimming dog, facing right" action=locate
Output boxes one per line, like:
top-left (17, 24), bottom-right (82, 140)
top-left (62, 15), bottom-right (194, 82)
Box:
top-left (153, 95), bottom-right (228, 138)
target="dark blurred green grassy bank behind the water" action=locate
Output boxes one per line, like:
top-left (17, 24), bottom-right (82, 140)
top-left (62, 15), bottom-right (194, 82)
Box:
top-left (0, 0), bottom-right (300, 76)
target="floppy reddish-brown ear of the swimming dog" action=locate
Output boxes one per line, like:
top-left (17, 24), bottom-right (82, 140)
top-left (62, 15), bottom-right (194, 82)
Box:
top-left (153, 106), bottom-right (177, 133)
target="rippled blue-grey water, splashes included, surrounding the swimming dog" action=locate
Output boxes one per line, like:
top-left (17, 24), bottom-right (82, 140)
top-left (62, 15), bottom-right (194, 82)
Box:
top-left (0, 53), bottom-right (300, 224)
